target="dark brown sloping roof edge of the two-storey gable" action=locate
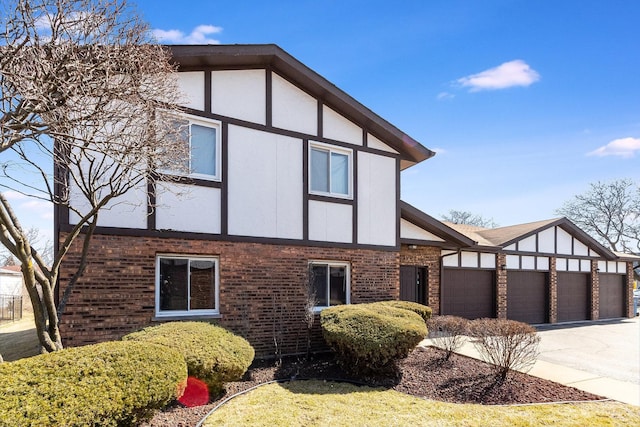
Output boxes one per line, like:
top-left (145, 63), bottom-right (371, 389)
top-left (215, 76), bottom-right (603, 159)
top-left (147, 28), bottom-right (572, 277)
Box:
top-left (166, 44), bottom-right (435, 169)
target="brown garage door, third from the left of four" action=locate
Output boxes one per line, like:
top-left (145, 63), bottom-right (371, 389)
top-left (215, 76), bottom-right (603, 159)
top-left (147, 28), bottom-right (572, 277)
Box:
top-left (558, 273), bottom-right (591, 322)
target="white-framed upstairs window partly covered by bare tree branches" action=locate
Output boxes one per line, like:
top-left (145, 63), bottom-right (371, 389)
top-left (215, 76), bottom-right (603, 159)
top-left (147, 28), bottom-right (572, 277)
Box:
top-left (165, 115), bottom-right (222, 181)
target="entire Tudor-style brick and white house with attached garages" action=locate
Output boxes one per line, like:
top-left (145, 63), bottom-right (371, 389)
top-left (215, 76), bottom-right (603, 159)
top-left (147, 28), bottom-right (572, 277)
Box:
top-left (56, 45), bottom-right (637, 356)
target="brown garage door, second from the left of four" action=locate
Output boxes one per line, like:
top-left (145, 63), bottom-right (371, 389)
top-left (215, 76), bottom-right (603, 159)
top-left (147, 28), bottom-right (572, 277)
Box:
top-left (507, 270), bottom-right (549, 323)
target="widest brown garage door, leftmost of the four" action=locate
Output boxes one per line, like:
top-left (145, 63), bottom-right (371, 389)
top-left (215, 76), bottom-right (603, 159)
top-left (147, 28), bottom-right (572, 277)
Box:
top-left (441, 268), bottom-right (496, 319)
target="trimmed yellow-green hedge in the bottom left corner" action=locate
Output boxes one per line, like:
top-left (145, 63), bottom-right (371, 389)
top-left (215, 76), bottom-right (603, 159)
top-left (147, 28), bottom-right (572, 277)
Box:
top-left (0, 342), bottom-right (187, 427)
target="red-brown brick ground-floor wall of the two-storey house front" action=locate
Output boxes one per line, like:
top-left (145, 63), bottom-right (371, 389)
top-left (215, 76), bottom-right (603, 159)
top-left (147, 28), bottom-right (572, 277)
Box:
top-left (60, 235), bottom-right (398, 356)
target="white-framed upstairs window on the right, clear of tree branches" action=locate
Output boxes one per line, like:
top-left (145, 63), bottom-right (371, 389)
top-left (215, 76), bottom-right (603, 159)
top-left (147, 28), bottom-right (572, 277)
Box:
top-left (309, 142), bottom-right (353, 198)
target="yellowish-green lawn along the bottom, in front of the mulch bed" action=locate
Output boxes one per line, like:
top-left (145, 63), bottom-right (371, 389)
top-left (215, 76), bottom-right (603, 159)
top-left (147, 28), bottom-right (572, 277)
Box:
top-left (204, 381), bottom-right (640, 427)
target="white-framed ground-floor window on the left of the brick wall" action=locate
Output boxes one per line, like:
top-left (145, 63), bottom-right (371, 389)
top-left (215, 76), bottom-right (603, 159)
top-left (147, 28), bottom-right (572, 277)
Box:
top-left (156, 255), bottom-right (220, 317)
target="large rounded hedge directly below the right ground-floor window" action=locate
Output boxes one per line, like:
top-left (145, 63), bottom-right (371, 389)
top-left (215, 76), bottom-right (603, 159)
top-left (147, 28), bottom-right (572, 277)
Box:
top-left (320, 304), bottom-right (427, 374)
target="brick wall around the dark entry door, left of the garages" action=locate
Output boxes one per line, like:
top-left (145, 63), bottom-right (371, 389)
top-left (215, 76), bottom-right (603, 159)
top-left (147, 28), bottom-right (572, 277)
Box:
top-left (400, 245), bottom-right (441, 315)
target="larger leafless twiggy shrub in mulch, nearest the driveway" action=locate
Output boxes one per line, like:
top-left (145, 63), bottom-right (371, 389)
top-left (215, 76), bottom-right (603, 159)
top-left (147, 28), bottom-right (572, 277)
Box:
top-left (469, 319), bottom-right (540, 381)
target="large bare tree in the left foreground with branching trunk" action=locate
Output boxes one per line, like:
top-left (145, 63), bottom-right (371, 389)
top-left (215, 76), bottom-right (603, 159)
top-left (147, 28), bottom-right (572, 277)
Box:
top-left (0, 0), bottom-right (186, 351)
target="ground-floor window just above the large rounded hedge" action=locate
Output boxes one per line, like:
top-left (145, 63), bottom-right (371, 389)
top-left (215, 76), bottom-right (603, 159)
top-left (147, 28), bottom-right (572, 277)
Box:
top-left (310, 262), bottom-right (350, 307)
